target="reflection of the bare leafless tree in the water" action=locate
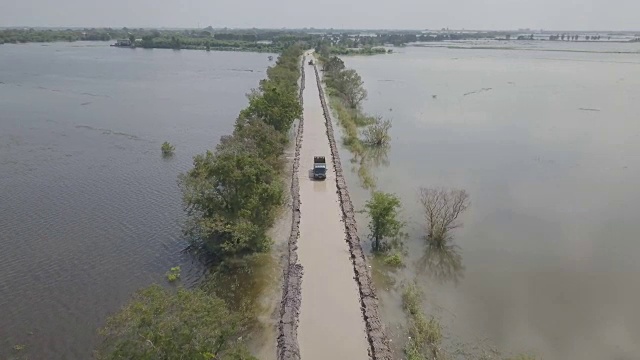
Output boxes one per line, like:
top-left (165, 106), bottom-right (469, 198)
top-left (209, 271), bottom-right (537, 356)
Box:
top-left (417, 241), bottom-right (465, 285)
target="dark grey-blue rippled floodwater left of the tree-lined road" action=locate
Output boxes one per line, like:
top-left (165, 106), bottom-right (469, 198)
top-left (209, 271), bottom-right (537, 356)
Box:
top-left (0, 43), bottom-right (269, 359)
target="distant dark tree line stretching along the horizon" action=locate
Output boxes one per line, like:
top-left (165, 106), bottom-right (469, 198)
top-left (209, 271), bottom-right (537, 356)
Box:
top-left (0, 26), bottom-right (632, 48)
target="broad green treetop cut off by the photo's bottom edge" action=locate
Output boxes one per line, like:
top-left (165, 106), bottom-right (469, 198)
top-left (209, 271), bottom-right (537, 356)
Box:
top-left (97, 285), bottom-right (255, 360)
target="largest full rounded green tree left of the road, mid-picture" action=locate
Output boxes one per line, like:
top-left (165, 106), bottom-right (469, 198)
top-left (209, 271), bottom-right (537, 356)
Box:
top-left (180, 148), bottom-right (284, 257)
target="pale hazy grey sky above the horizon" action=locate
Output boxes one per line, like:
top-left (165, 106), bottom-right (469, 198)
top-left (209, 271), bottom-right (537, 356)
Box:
top-left (0, 0), bottom-right (640, 30)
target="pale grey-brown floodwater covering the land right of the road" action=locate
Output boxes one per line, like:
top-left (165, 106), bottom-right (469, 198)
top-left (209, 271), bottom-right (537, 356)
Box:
top-left (343, 44), bottom-right (640, 360)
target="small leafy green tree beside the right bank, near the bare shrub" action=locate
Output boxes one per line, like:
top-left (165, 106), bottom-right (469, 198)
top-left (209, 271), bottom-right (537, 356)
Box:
top-left (365, 191), bottom-right (404, 251)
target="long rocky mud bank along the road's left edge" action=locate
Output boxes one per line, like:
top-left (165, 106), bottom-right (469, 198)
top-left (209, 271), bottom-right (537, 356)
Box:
top-left (277, 56), bottom-right (305, 360)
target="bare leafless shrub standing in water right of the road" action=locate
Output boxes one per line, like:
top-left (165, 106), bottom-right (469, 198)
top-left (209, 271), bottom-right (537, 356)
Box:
top-left (420, 187), bottom-right (469, 246)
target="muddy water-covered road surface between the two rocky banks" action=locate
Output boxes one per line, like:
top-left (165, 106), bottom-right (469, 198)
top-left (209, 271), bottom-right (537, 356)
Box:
top-left (298, 54), bottom-right (369, 360)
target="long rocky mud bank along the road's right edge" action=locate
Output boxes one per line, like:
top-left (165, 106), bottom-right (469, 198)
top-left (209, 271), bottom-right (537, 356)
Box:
top-left (312, 64), bottom-right (392, 360)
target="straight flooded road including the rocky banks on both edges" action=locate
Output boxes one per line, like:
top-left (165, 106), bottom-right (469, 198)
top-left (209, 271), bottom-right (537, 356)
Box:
top-left (278, 53), bottom-right (392, 360)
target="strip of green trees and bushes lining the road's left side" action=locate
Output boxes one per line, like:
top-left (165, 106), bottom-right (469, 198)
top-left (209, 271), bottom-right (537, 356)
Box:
top-left (96, 45), bottom-right (302, 360)
